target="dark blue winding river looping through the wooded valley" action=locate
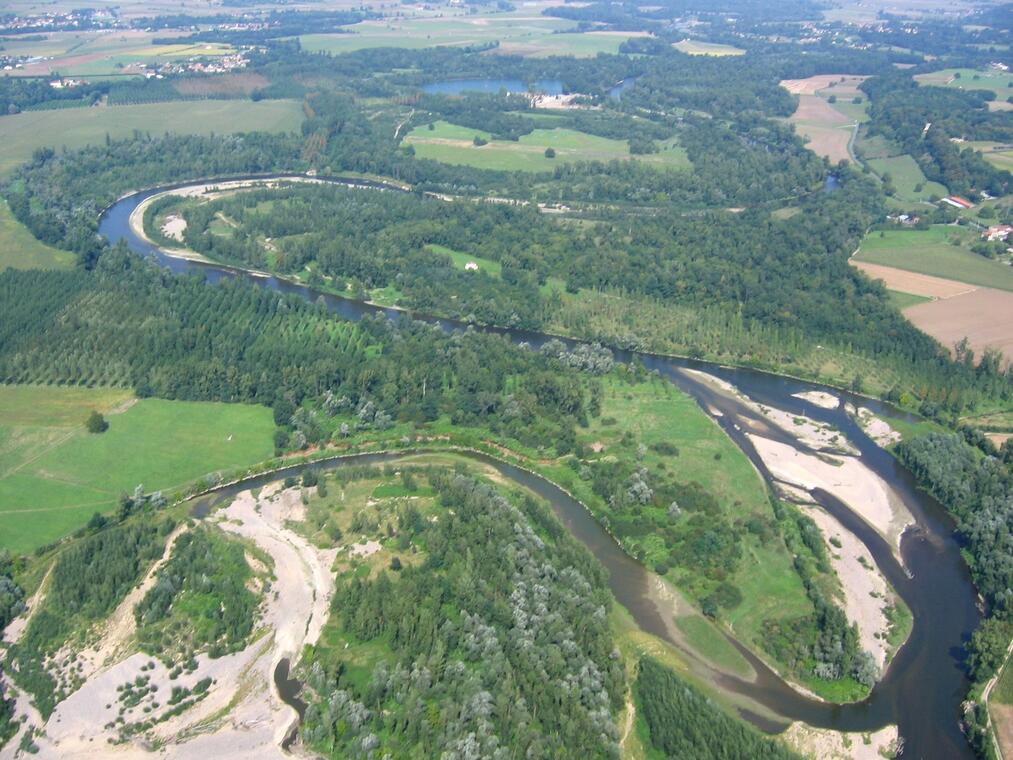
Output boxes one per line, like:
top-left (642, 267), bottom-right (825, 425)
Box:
top-left (99, 177), bottom-right (979, 760)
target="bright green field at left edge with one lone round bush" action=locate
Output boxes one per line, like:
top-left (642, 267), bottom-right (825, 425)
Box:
top-left (0, 386), bottom-right (274, 552)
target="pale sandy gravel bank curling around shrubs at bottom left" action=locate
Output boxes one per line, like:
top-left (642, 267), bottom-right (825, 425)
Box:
top-left (2, 484), bottom-right (336, 760)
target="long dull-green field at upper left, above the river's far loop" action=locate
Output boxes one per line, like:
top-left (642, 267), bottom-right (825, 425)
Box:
top-left (0, 100), bottom-right (303, 177)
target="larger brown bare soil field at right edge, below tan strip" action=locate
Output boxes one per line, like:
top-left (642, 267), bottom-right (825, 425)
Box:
top-left (904, 288), bottom-right (1013, 366)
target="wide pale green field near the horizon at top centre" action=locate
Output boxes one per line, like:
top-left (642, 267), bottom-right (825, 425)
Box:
top-left (299, 15), bottom-right (642, 58)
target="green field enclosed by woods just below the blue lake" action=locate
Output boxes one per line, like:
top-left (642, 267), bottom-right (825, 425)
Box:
top-left (405, 122), bottom-right (690, 171)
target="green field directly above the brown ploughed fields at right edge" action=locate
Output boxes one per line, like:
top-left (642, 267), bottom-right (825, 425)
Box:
top-left (855, 225), bottom-right (1013, 291)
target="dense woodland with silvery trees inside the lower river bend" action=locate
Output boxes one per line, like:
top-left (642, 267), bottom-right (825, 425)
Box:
top-left (302, 473), bottom-right (625, 760)
